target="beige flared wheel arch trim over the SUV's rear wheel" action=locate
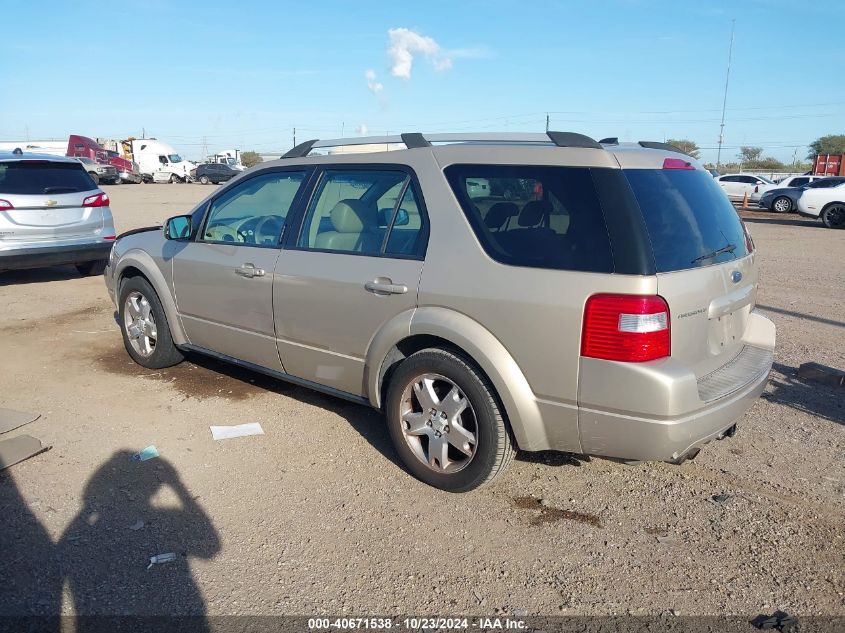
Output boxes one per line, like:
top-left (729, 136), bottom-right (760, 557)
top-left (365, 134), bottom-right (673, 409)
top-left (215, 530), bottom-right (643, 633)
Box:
top-left (364, 307), bottom-right (548, 450)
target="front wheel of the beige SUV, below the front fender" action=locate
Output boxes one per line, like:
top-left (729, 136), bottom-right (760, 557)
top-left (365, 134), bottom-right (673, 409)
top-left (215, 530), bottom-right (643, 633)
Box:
top-left (118, 277), bottom-right (184, 369)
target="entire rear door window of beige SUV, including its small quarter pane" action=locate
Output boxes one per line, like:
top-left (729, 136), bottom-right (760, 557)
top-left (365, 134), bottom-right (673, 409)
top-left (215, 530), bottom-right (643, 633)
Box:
top-left (297, 170), bottom-right (425, 257)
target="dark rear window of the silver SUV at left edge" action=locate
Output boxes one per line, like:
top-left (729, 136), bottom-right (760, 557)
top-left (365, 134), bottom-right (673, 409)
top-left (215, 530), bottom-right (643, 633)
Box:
top-left (0, 161), bottom-right (97, 195)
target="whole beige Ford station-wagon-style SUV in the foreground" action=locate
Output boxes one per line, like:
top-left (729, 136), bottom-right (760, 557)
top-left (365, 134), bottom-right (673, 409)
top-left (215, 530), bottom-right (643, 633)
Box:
top-left (105, 132), bottom-right (775, 491)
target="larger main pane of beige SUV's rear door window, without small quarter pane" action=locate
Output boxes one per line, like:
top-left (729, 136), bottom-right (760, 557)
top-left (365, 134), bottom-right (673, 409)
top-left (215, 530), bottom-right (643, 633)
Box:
top-left (297, 170), bottom-right (408, 255)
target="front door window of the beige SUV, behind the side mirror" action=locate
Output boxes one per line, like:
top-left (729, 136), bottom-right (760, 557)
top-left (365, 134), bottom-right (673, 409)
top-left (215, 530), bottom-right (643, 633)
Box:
top-left (200, 171), bottom-right (305, 246)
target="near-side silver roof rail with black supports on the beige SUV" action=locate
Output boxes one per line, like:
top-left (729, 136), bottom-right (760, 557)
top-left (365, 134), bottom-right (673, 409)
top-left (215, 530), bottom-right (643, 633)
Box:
top-left (282, 131), bottom-right (603, 158)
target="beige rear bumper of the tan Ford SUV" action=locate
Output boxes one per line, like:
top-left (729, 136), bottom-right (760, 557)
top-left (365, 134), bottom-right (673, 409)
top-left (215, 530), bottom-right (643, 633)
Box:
top-left (578, 313), bottom-right (775, 461)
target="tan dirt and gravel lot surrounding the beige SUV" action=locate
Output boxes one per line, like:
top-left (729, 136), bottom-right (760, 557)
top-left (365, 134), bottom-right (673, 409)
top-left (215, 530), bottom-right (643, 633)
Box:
top-left (0, 185), bottom-right (845, 615)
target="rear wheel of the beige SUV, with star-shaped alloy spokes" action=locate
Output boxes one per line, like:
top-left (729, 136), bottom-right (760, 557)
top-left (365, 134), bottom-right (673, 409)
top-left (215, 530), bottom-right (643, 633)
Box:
top-left (385, 349), bottom-right (515, 492)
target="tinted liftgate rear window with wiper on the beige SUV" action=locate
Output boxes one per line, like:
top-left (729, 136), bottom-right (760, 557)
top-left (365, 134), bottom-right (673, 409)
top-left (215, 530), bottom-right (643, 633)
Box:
top-left (625, 169), bottom-right (748, 272)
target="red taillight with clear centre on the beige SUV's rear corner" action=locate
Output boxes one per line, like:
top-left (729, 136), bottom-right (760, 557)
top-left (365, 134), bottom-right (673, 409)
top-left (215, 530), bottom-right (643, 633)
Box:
top-left (581, 294), bottom-right (672, 363)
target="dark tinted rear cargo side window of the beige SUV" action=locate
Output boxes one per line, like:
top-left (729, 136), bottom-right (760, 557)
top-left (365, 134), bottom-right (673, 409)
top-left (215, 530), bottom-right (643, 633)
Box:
top-left (445, 165), bottom-right (613, 273)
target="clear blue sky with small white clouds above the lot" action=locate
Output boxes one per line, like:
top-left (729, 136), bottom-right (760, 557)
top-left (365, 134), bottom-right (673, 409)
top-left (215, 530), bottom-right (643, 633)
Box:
top-left (0, 0), bottom-right (845, 162)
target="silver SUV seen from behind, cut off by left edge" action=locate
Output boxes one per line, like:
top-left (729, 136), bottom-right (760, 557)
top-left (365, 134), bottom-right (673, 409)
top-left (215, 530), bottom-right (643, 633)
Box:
top-left (0, 150), bottom-right (115, 275)
